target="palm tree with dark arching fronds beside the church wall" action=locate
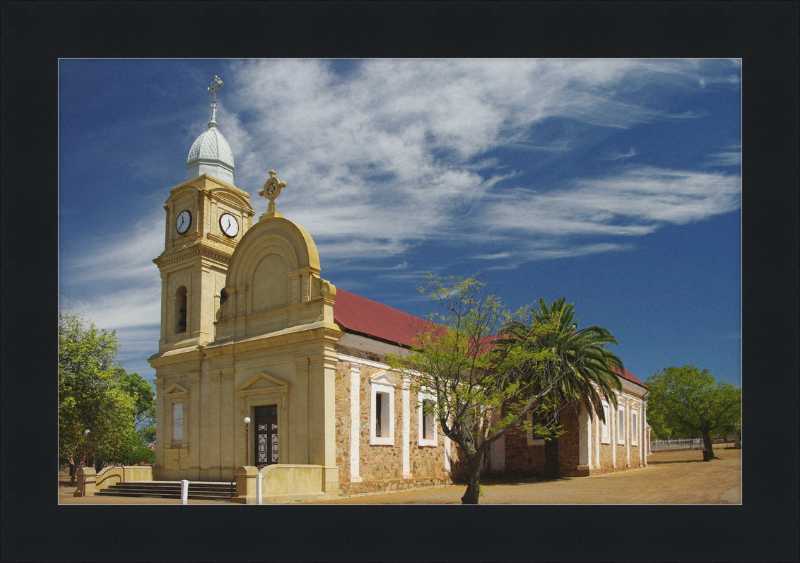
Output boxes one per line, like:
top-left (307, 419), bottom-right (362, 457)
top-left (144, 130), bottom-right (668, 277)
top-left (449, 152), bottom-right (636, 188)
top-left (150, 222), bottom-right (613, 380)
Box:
top-left (505, 297), bottom-right (624, 479)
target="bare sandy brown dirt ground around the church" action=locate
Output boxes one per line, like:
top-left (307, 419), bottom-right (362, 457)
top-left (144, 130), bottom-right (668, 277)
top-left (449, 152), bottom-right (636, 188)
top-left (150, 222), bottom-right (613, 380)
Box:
top-left (58, 445), bottom-right (742, 506)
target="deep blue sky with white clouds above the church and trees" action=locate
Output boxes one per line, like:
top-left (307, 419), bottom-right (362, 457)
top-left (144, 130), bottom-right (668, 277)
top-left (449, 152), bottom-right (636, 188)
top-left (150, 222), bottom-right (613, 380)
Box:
top-left (59, 59), bottom-right (741, 384)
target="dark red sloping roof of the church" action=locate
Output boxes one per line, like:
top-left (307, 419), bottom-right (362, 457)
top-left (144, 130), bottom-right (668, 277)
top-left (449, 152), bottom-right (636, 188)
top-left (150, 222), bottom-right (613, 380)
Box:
top-left (333, 288), bottom-right (647, 387)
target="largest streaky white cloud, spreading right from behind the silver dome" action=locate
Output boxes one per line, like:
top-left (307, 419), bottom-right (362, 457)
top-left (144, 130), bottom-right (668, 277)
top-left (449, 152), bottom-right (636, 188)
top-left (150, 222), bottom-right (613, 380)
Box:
top-left (219, 59), bottom-right (736, 268)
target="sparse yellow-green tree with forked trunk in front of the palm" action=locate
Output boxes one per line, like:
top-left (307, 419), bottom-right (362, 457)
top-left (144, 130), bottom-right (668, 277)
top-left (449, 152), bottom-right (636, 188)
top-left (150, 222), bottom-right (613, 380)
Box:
top-left (387, 274), bottom-right (554, 504)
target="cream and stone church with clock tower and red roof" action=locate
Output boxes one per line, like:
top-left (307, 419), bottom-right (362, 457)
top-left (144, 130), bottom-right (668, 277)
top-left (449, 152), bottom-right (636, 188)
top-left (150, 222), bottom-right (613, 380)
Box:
top-left (148, 77), bottom-right (647, 495)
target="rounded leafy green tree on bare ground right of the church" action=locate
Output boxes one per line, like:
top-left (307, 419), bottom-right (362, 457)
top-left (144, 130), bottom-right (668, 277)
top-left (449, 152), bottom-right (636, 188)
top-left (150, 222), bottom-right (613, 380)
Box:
top-left (646, 366), bottom-right (742, 458)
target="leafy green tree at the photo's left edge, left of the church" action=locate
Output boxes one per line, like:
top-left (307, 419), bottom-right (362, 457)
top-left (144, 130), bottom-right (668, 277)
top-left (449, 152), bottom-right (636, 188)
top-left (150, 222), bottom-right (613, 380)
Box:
top-left (58, 306), bottom-right (136, 480)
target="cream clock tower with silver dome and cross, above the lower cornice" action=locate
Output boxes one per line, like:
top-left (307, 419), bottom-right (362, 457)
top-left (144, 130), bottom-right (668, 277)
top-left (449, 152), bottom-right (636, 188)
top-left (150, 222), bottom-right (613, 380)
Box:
top-left (153, 76), bottom-right (255, 353)
